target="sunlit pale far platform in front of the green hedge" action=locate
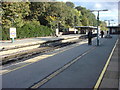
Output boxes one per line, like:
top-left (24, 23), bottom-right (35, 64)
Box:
top-left (0, 34), bottom-right (81, 50)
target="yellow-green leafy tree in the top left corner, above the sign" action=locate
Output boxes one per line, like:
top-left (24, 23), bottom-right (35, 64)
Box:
top-left (2, 2), bottom-right (30, 28)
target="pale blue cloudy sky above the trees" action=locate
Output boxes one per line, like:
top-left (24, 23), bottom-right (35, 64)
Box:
top-left (59, 0), bottom-right (120, 26)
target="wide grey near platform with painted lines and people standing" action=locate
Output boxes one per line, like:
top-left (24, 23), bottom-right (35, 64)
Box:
top-left (2, 35), bottom-right (120, 90)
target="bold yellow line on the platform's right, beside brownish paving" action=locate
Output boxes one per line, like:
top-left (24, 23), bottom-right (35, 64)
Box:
top-left (94, 40), bottom-right (118, 90)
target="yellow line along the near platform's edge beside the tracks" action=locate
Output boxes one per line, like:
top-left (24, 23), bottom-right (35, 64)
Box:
top-left (0, 41), bottom-right (86, 75)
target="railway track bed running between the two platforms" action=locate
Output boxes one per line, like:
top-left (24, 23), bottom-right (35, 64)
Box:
top-left (1, 36), bottom-right (86, 65)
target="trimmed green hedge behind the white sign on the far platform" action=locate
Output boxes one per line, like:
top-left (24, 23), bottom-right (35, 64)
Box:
top-left (2, 21), bottom-right (53, 40)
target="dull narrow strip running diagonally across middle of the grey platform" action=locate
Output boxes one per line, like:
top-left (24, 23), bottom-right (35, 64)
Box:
top-left (30, 47), bottom-right (96, 88)
